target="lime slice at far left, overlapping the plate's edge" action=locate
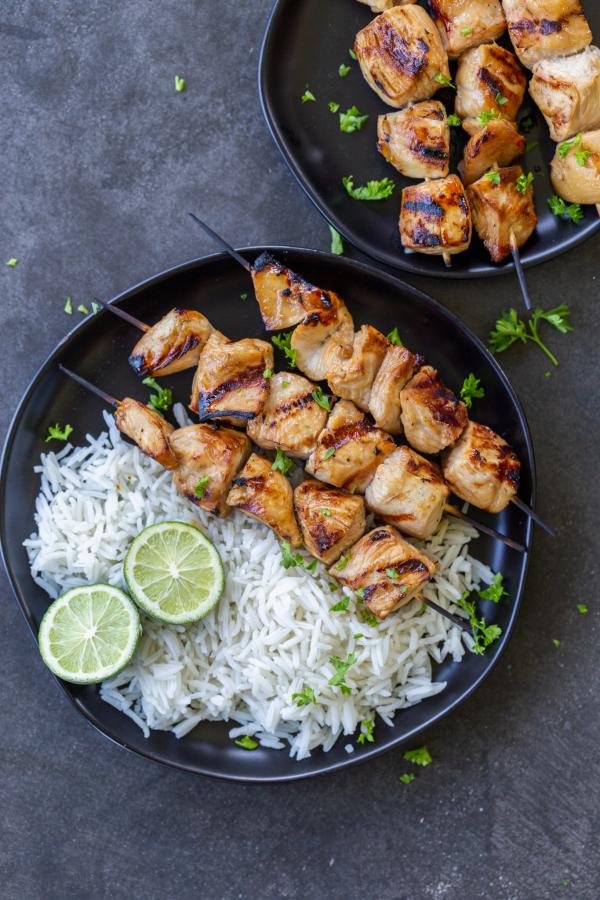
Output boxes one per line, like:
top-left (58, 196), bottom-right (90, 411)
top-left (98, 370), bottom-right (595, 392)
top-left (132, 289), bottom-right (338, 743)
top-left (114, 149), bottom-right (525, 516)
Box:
top-left (38, 584), bottom-right (142, 684)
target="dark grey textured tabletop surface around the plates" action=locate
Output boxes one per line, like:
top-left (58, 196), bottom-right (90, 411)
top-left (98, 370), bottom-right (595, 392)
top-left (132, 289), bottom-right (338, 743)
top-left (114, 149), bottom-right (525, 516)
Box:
top-left (0, 0), bottom-right (600, 900)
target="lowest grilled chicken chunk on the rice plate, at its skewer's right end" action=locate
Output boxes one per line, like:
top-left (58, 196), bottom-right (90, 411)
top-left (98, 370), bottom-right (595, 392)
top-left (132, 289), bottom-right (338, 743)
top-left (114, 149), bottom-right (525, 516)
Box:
top-left (329, 525), bottom-right (436, 619)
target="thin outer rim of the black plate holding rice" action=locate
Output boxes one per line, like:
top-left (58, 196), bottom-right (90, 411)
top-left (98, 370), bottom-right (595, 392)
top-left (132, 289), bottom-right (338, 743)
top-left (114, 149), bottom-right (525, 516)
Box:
top-left (0, 245), bottom-right (537, 784)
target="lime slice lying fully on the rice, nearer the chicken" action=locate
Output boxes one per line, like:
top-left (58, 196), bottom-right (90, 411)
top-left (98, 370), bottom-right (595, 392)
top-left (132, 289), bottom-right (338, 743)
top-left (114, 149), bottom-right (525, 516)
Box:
top-left (124, 522), bottom-right (225, 625)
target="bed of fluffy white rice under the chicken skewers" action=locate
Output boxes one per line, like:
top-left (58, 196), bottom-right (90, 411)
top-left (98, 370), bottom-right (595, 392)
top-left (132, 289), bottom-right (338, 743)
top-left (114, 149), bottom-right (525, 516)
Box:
top-left (25, 415), bottom-right (493, 759)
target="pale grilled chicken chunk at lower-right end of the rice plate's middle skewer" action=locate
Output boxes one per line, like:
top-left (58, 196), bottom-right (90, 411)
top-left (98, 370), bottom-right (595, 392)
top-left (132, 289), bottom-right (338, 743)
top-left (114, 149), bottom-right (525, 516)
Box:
top-left (365, 447), bottom-right (449, 539)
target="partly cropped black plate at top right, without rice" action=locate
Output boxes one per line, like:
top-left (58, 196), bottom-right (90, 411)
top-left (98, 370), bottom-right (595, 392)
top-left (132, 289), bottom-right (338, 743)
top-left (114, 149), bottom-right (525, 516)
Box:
top-left (259, 0), bottom-right (600, 278)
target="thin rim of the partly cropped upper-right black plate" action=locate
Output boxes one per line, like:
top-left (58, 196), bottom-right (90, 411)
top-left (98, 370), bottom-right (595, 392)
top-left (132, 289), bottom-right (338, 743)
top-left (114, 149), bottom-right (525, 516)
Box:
top-left (258, 0), bottom-right (600, 281)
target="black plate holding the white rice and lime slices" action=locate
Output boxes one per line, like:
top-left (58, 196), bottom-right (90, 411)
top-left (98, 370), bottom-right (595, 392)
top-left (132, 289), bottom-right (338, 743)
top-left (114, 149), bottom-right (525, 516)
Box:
top-left (0, 248), bottom-right (534, 781)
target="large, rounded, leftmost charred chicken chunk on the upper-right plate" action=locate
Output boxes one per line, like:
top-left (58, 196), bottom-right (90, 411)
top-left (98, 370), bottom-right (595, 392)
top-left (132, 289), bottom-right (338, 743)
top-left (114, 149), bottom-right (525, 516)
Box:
top-left (354, 5), bottom-right (450, 107)
